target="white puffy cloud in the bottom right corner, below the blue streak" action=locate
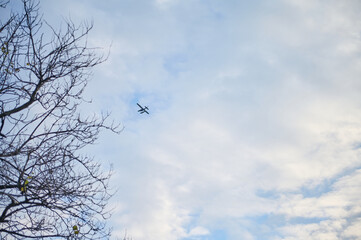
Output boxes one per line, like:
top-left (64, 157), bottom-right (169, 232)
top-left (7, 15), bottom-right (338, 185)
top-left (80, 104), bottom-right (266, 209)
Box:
top-left (272, 170), bottom-right (361, 239)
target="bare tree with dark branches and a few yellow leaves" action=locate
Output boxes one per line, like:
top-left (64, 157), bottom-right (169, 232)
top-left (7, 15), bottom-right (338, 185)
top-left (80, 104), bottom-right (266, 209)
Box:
top-left (0, 0), bottom-right (119, 239)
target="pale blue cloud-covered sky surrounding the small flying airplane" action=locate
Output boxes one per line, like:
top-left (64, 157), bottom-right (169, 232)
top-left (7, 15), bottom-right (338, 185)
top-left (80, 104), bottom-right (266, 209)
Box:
top-left (12, 0), bottom-right (361, 240)
